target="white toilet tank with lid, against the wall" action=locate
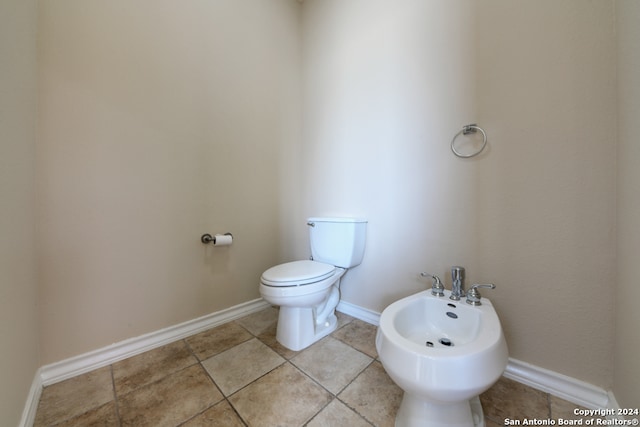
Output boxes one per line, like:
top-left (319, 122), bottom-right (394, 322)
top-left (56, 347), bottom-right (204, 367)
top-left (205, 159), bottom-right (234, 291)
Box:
top-left (307, 218), bottom-right (367, 268)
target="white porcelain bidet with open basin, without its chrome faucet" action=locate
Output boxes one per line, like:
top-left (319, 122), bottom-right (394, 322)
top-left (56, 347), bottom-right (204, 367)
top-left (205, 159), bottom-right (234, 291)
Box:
top-left (376, 291), bottom-right (508, 427)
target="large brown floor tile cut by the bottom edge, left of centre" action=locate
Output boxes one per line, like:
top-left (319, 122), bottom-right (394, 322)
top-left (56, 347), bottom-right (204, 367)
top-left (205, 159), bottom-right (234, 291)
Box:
top-left (118, 364), bottom-right (223, 427)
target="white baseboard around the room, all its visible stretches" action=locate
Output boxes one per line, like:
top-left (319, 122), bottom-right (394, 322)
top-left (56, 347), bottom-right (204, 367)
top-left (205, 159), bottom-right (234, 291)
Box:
top-left (19, 298), bottom-right (617, 427)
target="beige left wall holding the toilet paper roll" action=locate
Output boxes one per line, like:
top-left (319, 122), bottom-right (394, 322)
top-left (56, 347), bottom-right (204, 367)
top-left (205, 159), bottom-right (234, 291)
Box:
top-left (38, 0), bottom-right (300, 363)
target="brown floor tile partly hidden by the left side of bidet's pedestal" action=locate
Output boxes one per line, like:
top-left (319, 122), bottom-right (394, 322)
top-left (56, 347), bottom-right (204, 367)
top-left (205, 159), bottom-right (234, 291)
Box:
top-left (338, 361), bottom-right (403, 427)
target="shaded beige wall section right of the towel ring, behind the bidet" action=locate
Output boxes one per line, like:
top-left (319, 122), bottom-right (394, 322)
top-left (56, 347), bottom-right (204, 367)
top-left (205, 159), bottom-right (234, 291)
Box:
top-left (470, 0), bottom-right (616, 388)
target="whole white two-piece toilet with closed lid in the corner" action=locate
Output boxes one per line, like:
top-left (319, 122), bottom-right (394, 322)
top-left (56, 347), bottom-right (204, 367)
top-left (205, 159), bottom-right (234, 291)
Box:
top-left (260, 218), bottom-right (367, 351)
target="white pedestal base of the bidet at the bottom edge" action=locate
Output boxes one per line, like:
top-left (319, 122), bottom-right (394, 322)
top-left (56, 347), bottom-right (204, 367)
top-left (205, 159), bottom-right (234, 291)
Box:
top-left (395, 392), bottom-right (485, 427)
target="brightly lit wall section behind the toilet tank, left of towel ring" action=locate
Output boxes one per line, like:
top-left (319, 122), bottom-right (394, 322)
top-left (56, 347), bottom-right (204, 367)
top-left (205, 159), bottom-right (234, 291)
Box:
top-left (301, 0), bottom-right (475, 311)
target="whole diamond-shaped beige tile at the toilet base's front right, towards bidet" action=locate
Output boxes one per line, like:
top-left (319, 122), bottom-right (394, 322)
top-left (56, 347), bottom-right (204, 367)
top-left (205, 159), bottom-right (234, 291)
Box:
top-left (291, 336), bottom-right (373, 394)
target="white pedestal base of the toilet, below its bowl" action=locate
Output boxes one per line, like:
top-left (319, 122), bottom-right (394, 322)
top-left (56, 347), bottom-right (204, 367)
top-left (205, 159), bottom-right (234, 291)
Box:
top-left (276, 307), bottom-right (338, 351)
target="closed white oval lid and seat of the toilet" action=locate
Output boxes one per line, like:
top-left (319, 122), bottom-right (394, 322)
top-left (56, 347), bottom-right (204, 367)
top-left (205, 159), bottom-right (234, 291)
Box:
top-left (262, 260), bottom-right (336, 286)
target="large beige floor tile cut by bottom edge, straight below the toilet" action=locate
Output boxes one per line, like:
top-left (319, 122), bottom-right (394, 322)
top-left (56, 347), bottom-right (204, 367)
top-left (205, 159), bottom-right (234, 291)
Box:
top-left (229, 362), bottom-right (331, 427)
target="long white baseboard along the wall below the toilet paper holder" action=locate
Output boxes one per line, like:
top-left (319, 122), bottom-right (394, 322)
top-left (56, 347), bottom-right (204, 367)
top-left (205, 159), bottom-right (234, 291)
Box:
top-left (40, 298), bottom-right (269, 386)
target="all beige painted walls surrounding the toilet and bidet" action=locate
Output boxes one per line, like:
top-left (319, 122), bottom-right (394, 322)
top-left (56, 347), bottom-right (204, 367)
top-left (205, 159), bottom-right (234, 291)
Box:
top-left (0, 0), bottom-right (640, 412)
